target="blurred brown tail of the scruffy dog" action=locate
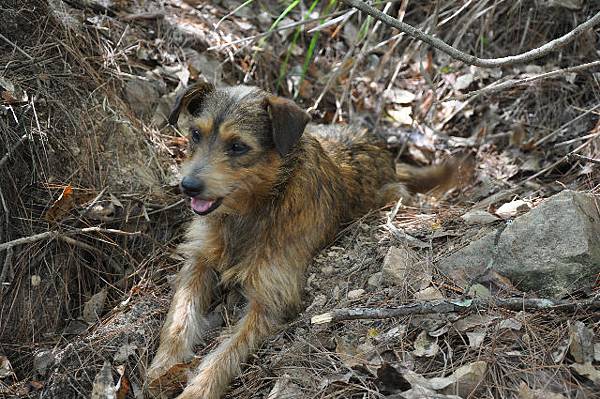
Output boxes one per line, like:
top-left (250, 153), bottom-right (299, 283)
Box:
top-left (396, 157), bottom-right (473, 195)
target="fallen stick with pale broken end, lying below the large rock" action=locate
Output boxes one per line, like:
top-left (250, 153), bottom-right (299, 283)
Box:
top-left (310, 298), bottom-right (600, 324)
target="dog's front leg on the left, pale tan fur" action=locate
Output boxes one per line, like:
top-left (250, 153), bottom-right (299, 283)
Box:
top-left (147, 256), bottom-right (216, 383)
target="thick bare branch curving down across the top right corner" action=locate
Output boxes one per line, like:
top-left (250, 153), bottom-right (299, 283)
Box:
top-left (342, 0), bottom-right (600, 68)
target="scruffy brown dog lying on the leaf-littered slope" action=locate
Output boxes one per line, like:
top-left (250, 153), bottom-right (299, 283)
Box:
top-left (148, 83), bottom-right (454, 399)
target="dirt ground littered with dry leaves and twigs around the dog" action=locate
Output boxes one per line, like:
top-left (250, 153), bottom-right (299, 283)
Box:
top-left (0, 0), bottom-right (600, 399)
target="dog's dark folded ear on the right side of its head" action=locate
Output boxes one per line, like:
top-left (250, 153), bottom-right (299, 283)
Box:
top-left (266, 96), bottom-right (310, 157)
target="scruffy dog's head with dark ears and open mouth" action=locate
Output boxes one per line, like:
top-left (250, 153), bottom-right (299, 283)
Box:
top-left (169, 83), bottom-right (310, 215)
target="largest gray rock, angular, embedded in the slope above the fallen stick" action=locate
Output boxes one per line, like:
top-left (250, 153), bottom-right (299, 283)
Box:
top-left (438, 190), bottom-right (600, 297)
